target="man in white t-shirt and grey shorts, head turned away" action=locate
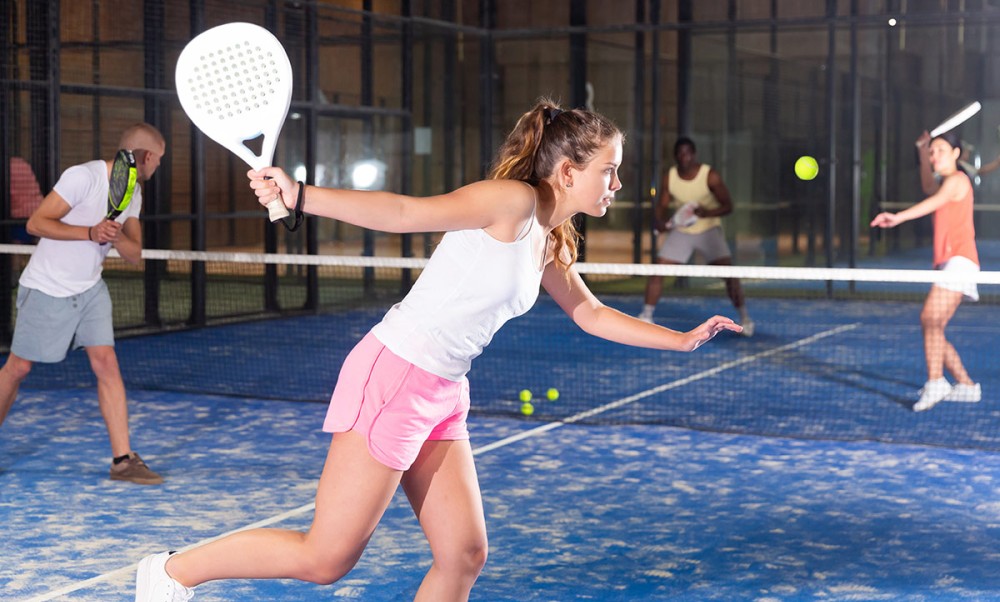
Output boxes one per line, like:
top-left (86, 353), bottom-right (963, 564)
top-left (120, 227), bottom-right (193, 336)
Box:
top-left (0, 123), bottom-right (166, 485)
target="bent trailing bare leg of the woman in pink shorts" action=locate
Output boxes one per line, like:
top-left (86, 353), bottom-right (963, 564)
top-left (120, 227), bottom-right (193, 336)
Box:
top-left (166, 432), bottom-right (402, 587)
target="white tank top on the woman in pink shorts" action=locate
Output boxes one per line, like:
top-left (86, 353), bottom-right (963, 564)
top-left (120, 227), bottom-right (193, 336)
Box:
top-left (372, 197), bottom-right (542, 381)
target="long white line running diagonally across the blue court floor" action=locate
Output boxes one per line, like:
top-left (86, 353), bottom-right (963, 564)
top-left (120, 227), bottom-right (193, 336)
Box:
top-left (27, 323), bottom-right (861, 602)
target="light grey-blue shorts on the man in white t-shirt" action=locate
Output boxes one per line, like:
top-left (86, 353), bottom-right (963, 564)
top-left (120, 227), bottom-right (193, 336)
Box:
top-left (10, 280), bottom-right (115, 363)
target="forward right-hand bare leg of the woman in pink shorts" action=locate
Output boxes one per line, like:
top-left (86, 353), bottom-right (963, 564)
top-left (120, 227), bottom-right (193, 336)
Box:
top-left (402, 440), bottom-right (488, 602)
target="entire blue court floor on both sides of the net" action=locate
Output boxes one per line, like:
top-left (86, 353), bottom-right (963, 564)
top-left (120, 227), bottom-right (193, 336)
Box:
top-left (0, 288), bottom-right (1000, 601)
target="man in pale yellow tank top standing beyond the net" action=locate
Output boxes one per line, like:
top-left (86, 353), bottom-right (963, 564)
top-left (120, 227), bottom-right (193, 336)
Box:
top-left (638, 137), bottom-right (754, 337)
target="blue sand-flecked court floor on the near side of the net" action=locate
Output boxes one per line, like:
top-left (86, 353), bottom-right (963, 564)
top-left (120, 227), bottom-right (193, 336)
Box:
top-left (0, 389), bottom-right (1000, 602)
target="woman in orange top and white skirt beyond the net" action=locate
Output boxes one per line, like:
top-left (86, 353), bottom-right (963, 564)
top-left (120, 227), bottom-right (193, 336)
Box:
top-left (871, 132), bottom-right (982, 412)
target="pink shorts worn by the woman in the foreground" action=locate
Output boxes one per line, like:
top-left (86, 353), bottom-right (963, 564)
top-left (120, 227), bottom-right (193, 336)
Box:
top-left (323, 333), bottom-right (469, 470)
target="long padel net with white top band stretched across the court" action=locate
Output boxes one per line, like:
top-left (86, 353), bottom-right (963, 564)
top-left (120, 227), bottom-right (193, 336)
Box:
top-left (0, 245), bottom-right (1000, 450)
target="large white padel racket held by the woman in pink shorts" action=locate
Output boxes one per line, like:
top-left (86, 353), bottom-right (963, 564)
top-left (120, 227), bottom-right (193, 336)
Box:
top-left (175, 23), bottom-right (292, 222)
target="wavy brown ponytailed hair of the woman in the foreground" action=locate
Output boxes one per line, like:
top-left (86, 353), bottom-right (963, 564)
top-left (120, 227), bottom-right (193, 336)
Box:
top-left (489, 98), bottom-right (622, 268)
